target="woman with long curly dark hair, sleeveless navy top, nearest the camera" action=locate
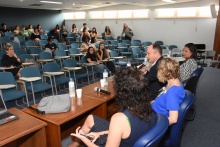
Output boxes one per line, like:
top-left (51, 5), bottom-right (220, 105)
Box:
top-left (70, 67), bottom-right (155, 147)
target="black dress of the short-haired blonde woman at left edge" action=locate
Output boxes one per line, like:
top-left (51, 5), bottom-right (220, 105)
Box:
top-left (1, 54), bottom-right (22, 76)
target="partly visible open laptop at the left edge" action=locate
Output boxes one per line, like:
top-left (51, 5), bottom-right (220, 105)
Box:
top-left (0, 95), bottom-right (19, 125)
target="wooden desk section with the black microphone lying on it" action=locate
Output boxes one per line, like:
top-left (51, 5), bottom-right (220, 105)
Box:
top-left (82, 77), bottom-right (116, 120)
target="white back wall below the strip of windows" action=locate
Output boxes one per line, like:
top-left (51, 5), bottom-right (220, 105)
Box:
top-left (65, 10), bottom-right (216, 49)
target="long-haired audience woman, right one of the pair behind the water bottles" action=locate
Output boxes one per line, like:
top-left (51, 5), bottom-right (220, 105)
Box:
top-left (96, 43), bottom-right (115, 73)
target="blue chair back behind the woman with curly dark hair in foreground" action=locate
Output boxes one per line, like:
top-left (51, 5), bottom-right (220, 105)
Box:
top-left (133, 114), bottom-right (169, 147)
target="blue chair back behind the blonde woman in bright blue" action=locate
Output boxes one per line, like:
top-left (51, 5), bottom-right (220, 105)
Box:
top-left (161, 90), bottom-right (195, 147)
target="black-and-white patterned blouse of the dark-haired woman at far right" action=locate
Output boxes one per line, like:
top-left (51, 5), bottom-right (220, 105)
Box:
top-left (180, 58), bottom-right (197, 81)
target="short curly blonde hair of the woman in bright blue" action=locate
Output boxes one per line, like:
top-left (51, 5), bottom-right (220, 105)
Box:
top-left (157, 58), bottom-right (180, 83)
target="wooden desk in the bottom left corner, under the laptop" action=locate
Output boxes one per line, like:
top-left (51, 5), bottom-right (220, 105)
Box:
top-left (0, 108), bottom-right (47, 147)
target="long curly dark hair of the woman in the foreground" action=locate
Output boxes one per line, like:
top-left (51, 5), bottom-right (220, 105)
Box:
top-left (113, 67), bottom-right (153, 121)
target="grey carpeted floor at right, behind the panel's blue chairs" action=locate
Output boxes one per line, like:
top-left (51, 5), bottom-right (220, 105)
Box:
top-left (181, 68), bottom-right (220, 147)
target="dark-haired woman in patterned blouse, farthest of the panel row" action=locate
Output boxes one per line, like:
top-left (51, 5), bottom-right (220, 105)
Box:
top-left (180, 43), bottom-right (197, 81)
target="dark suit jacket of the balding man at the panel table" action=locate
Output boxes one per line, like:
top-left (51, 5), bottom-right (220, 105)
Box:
top-left (145, 57), bottom-right (165, 100)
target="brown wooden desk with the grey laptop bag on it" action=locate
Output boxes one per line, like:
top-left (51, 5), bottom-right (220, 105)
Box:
top-left (23, 95), bottom-right (106, 147)
